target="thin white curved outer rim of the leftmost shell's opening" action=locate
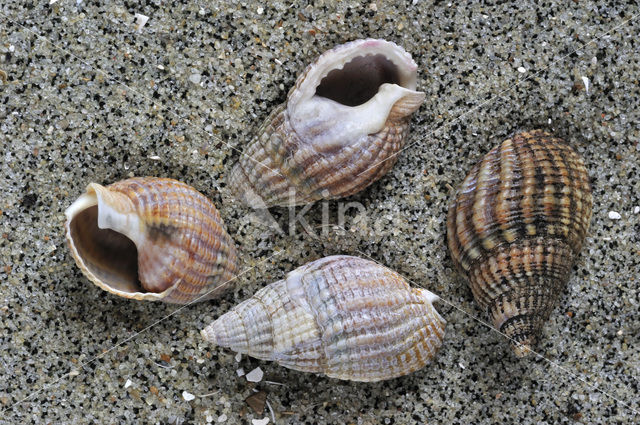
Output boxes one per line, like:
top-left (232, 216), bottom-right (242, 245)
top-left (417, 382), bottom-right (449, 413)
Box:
top-left (64, 183), bottom-right (178, 301)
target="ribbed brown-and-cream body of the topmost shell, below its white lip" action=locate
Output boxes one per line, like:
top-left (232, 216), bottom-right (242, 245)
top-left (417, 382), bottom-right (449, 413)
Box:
top-left (229, 105), bottom-right (410, 206)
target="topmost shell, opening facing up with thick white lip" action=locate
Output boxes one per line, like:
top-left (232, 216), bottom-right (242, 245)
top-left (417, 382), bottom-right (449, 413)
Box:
top-left (229, 40), bottom-right (425, 207)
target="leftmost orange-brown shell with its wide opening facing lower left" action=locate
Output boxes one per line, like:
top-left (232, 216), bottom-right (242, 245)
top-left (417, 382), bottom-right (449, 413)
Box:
top-left (65, 177), bottom-right (237, 304)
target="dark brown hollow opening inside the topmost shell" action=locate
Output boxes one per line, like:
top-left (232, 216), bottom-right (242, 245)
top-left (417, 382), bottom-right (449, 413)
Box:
top-left (315, 54), bottom-right (402, 106)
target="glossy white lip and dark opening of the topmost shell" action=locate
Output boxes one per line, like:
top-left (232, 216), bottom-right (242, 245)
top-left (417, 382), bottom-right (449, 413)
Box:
top-left (286, 39), bottom-right (424, 149)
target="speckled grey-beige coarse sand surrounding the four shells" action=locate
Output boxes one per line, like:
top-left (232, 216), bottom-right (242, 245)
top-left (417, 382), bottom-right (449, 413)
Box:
top-left (0, 0), bottom-right (640, 424)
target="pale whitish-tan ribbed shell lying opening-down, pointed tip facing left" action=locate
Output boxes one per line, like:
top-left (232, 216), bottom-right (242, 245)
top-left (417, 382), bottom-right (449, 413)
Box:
top-left (202, 256), bottom-right (446, 381)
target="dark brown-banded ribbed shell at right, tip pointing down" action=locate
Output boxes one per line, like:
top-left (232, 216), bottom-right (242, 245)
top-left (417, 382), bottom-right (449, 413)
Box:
top-left (447, 130), bottom-right (593, 357)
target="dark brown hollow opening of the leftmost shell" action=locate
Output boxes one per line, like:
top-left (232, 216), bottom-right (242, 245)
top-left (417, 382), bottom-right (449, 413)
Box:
top-left (68, 201), bottom-right (145, 293)
